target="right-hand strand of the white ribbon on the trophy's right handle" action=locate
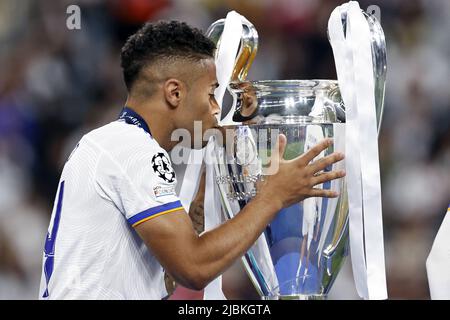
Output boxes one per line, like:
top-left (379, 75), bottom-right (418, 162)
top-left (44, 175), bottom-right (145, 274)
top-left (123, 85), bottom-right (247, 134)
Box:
top-left (349, 2), bottom-right (387, 299)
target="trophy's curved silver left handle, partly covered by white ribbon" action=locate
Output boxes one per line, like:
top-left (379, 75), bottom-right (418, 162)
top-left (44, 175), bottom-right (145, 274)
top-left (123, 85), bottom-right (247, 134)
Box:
top-left (206, 16), bottom-right (258, 82)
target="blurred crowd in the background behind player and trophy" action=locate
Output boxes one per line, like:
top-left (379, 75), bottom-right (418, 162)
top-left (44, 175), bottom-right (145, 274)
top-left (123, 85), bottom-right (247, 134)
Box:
top-left (0, 0), bottom-right (450, 299)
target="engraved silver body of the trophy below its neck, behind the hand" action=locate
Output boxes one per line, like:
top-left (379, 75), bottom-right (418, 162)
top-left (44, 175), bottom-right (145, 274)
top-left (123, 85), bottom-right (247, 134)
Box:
top-left (215, 123), bottom-right (348, 299)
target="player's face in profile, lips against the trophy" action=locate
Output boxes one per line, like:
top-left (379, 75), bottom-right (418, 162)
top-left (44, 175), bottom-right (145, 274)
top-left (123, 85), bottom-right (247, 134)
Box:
top-left (184, 59), bottom-right (220, 147)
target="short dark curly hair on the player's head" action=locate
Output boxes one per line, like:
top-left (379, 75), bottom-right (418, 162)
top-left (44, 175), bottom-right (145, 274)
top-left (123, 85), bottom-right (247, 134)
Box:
top-left (121, 21), bottom-right (215, 91)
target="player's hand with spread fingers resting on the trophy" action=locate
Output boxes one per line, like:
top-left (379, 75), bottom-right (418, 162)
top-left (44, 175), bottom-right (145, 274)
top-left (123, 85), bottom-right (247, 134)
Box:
top-left (258, 134), bottom-right (345, 209)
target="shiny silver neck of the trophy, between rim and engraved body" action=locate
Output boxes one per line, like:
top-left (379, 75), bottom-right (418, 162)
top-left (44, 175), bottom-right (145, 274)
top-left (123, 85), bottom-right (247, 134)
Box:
top-left (229, 80), bottom-right (345, 124)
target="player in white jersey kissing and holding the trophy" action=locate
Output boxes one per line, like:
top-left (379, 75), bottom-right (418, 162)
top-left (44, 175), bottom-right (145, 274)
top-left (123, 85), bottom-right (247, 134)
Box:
top-left (39, 21), bottom-right (344, 299)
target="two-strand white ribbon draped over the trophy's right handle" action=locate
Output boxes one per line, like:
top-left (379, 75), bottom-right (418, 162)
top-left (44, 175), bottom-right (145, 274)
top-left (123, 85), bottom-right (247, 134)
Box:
top-left (328, 1), bottom-right (387, 299)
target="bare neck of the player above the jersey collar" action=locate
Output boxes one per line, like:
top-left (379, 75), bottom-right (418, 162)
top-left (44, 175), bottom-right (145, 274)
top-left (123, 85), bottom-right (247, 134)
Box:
top-left (125, 98), bottom-right (178, 152)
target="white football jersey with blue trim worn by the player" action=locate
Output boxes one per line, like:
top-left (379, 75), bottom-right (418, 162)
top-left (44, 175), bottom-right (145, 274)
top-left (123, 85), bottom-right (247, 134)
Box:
top-left (39, 119), bottom-right (182, 299)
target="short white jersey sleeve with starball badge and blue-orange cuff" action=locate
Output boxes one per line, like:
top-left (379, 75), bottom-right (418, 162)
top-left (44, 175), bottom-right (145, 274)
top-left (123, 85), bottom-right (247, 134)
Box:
top-left (96, 148), bottom-right (183, 227)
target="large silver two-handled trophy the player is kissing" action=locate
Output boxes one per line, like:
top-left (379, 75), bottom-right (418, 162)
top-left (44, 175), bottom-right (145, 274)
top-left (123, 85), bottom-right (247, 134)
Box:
top-left (207, 10), bottom-right (386, 300)
